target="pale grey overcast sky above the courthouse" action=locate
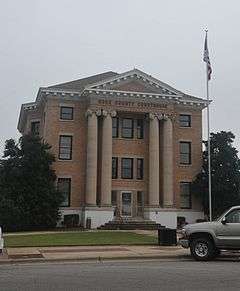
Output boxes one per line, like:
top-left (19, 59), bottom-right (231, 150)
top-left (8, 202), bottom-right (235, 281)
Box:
top-left (0, 0), bottom-right (240, 154)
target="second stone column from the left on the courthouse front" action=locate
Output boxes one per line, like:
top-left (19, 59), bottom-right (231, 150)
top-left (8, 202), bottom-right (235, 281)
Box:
top-left (101, 110), bottom-right (115, 206)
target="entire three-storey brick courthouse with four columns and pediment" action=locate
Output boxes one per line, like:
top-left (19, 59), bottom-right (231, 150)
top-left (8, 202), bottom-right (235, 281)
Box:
top-left (18, 69), bottom-right (207, 228)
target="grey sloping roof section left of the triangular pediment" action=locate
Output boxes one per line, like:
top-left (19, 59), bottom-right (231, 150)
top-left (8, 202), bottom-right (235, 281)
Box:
top-left (47, 71), bottom-right (119, 92)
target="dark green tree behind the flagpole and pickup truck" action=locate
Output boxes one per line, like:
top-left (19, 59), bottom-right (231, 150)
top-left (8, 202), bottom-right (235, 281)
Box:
top-left (193, 131), bottom-right (240, 217)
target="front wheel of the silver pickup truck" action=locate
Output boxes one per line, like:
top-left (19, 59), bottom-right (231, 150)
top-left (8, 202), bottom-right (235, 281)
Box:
top-left (190, 237), bottom-right (215, 261)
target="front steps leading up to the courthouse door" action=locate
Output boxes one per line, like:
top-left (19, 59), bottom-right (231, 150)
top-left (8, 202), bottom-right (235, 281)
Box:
top-left (97, 219), bottom-right (165, 230)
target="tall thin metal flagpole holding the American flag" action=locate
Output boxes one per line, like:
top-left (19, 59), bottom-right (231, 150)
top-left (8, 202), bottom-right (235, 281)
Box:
top-left (205, 29), bottom-right (212, 221)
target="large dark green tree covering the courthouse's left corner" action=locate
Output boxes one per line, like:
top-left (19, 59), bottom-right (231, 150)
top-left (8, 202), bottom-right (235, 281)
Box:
top-left (0, 135), bottom-right (62, 230)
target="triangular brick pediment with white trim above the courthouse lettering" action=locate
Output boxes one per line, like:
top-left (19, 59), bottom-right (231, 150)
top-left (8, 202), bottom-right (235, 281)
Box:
top-left (86, 69), bottom-right (182, 96)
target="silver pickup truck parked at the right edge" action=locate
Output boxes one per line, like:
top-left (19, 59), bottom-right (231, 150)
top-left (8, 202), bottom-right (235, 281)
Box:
top-left (179, 206), bottom-right (240, 261)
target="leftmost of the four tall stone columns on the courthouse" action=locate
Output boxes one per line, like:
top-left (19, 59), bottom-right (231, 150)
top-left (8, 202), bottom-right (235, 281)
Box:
top-left (85, 110), bottom-right (98, 206)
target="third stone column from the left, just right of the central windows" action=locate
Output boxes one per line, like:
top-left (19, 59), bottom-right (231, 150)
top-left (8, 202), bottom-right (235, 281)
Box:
top-left (149, 113), bottom-right (159, 207)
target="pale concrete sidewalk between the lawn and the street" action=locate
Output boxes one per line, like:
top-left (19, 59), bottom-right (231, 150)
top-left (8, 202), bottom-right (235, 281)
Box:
top-left (0, 245), bottom-right (189, 264)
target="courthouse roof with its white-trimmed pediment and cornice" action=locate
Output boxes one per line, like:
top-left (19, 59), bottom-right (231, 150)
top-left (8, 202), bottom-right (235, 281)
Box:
top-left (36, 68), bottom-right (208, 106)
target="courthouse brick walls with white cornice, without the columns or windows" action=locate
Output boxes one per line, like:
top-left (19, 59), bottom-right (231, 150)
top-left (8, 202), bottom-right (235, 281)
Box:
top-left (18, 70), bottom-right (206, 228)
